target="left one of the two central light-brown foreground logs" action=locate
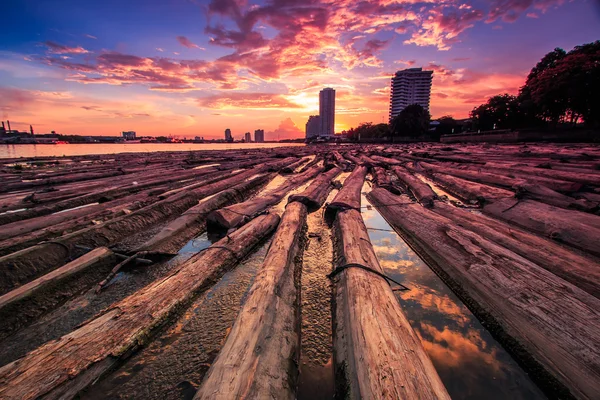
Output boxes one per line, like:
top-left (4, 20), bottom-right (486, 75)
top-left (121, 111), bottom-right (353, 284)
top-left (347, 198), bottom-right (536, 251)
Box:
top-left (194, 202), bottom-right (307, 400)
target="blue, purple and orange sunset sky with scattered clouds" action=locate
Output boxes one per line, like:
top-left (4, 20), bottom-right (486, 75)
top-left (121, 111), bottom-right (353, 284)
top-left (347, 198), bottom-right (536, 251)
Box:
top-left (0, 0), bottom-right (600, 140)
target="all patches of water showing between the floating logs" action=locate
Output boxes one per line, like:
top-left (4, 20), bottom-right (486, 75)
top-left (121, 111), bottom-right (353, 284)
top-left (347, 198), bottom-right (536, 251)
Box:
top-left (62, 173), bottom-right (544, 400)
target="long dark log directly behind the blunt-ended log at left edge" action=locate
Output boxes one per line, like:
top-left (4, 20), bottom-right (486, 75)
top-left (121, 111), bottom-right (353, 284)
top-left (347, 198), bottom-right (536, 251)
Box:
top-left (0, 168), bottom-right (263, 294)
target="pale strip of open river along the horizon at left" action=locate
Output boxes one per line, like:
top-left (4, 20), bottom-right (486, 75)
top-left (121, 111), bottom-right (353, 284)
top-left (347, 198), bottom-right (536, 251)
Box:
top-left (0, 143), bottom-right (304, 159)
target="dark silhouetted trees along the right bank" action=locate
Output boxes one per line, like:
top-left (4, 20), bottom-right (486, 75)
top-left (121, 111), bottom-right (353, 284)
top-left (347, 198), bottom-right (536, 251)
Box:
top-left (343, 41), bottom-right (600, 140)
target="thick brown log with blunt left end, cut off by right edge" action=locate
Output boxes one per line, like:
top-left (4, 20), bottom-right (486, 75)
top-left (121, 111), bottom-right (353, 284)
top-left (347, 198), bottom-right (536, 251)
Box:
top-left (483, 199), bottom-right (600, 256)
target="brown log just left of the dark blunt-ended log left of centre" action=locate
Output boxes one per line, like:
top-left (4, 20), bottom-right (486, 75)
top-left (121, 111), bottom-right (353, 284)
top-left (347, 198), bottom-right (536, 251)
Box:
top-left (136, 174), bottom-right (273, 253)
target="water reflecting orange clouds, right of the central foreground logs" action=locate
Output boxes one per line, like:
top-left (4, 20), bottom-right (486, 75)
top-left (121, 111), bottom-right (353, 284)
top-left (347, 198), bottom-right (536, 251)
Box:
top-left (362, 186), bottom-right (544, 399)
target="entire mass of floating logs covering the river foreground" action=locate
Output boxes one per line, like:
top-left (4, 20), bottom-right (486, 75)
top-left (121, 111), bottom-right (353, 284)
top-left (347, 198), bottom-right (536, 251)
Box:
top-left (0, 143), bottom-right (600, 399)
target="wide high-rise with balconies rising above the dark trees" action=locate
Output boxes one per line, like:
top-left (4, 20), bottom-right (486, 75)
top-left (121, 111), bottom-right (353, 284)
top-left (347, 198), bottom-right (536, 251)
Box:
top-left (390, 68), bottom-right (433, 121)
